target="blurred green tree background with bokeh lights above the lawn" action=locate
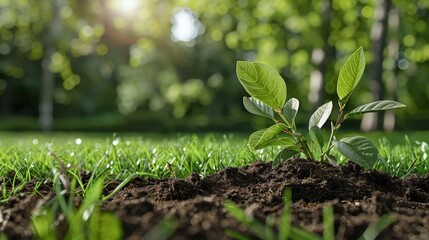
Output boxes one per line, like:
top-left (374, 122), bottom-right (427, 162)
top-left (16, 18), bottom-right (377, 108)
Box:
top-left (0, 0), bottom-right (429, 131)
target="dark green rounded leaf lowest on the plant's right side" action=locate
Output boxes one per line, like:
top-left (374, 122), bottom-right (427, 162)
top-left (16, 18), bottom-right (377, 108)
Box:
top-left (336, 136), bottom-right (378, 168)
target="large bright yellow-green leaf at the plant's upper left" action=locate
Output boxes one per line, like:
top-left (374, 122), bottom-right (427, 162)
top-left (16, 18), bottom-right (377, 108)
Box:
top-left (236, 61), bottom-right (287, 111)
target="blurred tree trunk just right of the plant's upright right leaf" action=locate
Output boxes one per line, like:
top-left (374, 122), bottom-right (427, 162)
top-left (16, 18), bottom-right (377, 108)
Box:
top-left (361, 0), bottom-right (391, 132)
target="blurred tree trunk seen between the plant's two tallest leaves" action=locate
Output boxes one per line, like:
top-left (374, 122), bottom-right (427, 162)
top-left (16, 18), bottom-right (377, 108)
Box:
top-left (308, 0), bottom-right (335, 110)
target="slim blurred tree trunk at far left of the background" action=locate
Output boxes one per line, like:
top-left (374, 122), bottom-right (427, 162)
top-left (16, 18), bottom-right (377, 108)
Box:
top-left (39, 0), bottom-right (63, 132)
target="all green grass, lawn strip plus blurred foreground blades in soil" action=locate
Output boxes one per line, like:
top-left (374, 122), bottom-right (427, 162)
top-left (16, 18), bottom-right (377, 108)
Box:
top-left (0, 132), bottom-right (429, 239)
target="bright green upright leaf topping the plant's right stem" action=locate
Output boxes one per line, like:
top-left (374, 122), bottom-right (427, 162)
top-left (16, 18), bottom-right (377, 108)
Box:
top-left (337, 47), bottom-right (365, 105)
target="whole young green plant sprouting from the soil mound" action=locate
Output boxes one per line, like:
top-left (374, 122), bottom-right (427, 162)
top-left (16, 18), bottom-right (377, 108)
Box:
top-left (236, 47), bottom-right (405, 168)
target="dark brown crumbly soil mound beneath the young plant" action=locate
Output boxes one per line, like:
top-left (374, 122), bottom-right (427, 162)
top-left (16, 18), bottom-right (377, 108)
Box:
top-left (0, 159), bottom-right (429, 240)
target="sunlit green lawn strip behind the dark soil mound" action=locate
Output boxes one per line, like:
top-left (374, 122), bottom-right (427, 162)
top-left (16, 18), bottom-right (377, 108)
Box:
top-left (0, 129), bottom-right (429, 195)
